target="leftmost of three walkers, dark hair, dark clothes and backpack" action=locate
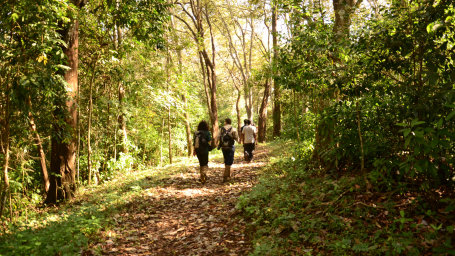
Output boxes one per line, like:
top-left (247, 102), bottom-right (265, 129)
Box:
top-left (193, 120), bottom-right (212, 184)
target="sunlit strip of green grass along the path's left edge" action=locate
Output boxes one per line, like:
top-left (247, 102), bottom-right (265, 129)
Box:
top-left (0, 153), bottom-right (203, 255)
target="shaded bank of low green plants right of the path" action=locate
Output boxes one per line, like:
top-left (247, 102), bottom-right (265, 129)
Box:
top-left (237, 143), bottom-right (455, 255)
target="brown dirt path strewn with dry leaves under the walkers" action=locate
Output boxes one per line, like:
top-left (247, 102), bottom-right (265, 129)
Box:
top-left (93, 145), bottom-right (268, 255)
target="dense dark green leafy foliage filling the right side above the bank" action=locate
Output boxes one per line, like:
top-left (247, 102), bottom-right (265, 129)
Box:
top-left (278, 1), bottom-right (455, 192)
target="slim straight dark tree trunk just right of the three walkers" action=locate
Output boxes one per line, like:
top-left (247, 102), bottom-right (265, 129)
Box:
top-left (272, 0), bottom-right (281, 137)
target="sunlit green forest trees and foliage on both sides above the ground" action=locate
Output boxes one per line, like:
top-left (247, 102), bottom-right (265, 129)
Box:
top-left (0, 0), bottom-right (455, 254)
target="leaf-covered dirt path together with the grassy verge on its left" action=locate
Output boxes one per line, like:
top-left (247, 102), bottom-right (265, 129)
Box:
top-left (0, 143), bottom-right (281, 256)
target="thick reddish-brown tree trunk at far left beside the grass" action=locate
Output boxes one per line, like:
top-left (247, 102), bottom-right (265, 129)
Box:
top-left (45, 15), bottom-right (80, 204)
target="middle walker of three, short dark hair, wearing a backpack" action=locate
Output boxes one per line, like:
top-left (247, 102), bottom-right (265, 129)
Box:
top-left (218, 118), bottom-right (239, 182)
